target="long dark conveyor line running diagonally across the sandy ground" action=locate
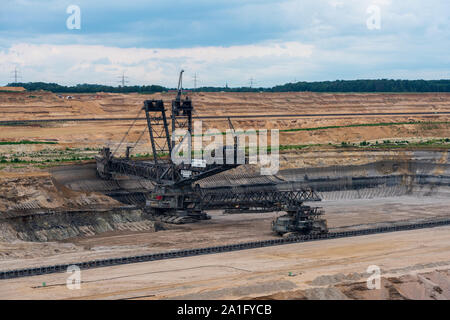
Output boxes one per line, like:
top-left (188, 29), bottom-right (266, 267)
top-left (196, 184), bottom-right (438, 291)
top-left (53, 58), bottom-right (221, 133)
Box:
top-left (0, 219), bottom-right (450, 279)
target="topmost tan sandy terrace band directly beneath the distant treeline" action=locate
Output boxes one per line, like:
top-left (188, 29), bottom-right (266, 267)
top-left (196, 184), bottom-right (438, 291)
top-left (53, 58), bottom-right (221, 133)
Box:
top-left (0, 91), bottom-right (450, 120)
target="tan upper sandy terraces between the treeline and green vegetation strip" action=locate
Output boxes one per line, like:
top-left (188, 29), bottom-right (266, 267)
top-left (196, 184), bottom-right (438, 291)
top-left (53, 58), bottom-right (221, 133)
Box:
top-left (0, 92), bottom-right (450, 153)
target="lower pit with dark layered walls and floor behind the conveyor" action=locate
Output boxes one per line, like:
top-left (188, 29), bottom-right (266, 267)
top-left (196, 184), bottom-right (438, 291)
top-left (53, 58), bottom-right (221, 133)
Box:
top-left (0, 151), bottom-right (450, 269)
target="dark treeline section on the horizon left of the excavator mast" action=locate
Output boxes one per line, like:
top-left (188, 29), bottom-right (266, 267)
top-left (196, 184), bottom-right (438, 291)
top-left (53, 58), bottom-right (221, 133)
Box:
top-left (8, 82), bottom-right (167, 93)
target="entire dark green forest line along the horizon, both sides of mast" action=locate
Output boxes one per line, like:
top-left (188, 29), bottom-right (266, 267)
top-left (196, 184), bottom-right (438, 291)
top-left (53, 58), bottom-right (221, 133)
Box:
top-left (8, 79), bottom-right (450, 93)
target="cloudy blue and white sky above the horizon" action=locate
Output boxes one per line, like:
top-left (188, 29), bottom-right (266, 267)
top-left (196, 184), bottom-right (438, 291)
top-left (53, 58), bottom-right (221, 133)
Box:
top-left (0, 0), bottom-right (450, 87)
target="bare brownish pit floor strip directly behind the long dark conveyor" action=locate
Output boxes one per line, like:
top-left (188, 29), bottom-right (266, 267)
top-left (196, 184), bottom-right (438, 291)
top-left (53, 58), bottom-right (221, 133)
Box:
top-left (0, 197), bottom-right (450, 270)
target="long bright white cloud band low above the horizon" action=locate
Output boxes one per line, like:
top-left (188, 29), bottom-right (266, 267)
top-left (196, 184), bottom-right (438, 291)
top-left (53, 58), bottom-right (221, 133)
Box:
top-left (0, 42), bottom-right (314, 86)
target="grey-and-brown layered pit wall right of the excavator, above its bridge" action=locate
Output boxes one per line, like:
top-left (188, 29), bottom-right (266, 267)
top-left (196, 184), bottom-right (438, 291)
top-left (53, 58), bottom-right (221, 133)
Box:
top-left (201, 151), bottom-right (450, 200)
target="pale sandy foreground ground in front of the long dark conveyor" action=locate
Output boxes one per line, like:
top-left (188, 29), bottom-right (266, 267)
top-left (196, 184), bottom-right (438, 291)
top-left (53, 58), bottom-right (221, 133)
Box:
top-left (0, 227), bottom-right (450, 299)
